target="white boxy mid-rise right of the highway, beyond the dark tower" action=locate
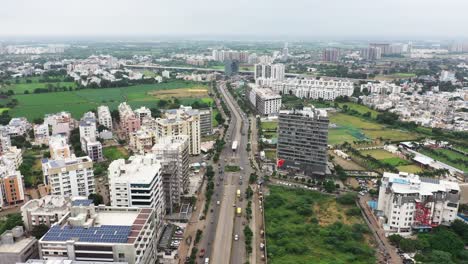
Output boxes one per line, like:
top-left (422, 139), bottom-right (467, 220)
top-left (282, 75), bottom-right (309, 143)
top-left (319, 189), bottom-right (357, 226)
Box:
top-left (246, 84), bottom-right (281, 115)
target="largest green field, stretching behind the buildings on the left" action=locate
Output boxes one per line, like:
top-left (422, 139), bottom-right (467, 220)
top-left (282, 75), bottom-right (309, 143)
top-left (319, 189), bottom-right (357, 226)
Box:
top-left (10, 81), bottom-right (213, 120)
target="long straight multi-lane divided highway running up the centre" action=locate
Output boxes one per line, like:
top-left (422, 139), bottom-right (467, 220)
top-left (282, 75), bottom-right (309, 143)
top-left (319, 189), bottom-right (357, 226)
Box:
top-left (199, 82), bottom-right (251, 264)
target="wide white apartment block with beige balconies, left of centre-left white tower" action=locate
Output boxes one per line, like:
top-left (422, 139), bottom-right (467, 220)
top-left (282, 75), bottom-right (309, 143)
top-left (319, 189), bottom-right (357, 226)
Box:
top-left (42, 156), bottom-right (95, 197)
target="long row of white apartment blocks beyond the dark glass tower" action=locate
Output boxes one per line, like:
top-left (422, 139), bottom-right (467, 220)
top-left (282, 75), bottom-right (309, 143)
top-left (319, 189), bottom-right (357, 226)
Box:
top-left (270, 79), bottom-right (354, 101)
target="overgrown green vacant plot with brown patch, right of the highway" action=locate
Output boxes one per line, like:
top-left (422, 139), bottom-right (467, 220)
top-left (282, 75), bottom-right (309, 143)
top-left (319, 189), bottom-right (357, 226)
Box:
top-left (265, 186), bottom-right (375, 264)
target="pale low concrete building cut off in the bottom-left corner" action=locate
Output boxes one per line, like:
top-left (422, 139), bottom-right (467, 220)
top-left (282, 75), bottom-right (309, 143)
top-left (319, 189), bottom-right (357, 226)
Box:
top-left (0, 226), bottom-right (39, 264)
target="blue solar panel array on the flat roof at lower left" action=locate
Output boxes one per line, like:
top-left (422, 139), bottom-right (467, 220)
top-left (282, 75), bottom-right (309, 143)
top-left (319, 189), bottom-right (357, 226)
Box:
top-left (43, 225), bottom-right (132, 243)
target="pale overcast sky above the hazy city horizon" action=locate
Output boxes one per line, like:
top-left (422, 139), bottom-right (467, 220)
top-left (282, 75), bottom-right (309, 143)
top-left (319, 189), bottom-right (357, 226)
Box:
top-left (0, 0), bottom-right (468, 38)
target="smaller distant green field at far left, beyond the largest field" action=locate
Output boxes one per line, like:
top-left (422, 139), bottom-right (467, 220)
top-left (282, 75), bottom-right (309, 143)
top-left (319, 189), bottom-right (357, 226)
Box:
top-left (0, 76), bottom-right (76, 94)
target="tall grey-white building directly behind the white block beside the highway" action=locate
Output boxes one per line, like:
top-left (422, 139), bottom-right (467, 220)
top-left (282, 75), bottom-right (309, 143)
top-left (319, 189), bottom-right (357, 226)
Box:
top-left (153, 135), bottom-right (190, 212)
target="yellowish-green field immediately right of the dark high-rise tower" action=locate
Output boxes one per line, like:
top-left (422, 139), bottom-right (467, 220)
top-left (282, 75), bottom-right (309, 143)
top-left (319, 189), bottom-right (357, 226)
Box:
top-left (328, 113), bottom-right (418, 144)
